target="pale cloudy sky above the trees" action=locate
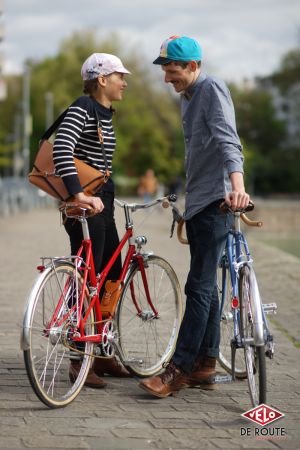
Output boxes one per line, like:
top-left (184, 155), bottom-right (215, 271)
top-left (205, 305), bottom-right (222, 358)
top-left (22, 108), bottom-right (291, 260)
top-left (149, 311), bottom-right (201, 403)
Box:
top-left (0, 0), bottom-right (300, 82)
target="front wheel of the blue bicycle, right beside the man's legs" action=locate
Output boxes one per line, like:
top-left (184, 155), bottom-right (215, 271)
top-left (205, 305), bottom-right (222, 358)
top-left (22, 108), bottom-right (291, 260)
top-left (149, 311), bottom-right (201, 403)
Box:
top-left (217, 260), bottom-right (247, 379)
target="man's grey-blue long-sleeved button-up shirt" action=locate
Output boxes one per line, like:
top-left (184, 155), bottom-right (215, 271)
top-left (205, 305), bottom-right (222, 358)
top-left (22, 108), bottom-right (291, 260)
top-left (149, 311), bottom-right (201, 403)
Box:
top-left (181, 74), bottom-right (243, 220)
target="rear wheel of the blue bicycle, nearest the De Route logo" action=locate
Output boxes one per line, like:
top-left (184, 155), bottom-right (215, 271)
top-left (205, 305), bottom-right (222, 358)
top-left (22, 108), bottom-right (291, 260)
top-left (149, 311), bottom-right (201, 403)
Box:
top-left (239, 265), bottom-right (267, 406)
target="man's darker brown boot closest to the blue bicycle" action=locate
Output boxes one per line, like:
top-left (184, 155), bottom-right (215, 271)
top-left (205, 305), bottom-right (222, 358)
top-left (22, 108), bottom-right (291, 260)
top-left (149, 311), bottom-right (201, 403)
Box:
top-left (186, 356), bottom-right (217, 390)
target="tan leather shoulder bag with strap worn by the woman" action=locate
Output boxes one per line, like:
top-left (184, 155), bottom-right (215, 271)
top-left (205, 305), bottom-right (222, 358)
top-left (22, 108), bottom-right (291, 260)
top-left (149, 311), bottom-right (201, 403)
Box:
top-left (28, 102), bottom-right (110, 201)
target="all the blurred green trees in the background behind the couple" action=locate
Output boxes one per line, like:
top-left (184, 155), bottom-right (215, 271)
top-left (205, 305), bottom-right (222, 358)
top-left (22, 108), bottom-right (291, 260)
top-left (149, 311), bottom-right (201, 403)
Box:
top-left (0, 31), bottom-right (300, 193)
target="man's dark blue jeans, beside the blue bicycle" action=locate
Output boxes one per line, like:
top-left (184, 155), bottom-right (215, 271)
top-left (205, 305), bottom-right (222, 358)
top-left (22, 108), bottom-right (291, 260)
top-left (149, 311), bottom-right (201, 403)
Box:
top-left (172, 200), bottom-right (232, 373)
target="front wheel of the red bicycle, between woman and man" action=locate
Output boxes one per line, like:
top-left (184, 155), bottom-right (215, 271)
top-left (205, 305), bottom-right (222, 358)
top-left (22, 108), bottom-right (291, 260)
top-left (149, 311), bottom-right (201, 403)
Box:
top-left (117, 255), bottom-right (182, 377)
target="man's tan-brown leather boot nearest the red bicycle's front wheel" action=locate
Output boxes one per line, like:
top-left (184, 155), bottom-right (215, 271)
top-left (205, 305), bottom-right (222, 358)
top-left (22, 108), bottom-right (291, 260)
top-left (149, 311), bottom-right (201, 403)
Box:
top-left (139, 361), bottom-right (188, 398)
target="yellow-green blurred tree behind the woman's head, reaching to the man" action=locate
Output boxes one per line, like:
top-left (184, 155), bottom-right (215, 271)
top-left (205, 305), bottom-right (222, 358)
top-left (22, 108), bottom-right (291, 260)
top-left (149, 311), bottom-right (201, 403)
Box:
top-left (27, 32), bottom-right (183, 185)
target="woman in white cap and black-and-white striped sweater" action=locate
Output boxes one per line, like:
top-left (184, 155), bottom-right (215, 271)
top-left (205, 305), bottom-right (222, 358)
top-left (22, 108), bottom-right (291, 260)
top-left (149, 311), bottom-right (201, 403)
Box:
top-left (53, 53), bottom-right (130, 388)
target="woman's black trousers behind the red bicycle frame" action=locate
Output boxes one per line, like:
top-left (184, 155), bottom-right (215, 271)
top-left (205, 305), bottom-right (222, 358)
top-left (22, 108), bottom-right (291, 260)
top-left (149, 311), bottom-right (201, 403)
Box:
top-left (65, 192), bottom-right (121, 280)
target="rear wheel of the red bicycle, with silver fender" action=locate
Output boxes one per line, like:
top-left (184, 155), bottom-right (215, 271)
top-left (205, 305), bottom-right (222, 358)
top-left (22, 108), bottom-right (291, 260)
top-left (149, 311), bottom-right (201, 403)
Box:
top-left (23, 262), bottom-right (94, 408)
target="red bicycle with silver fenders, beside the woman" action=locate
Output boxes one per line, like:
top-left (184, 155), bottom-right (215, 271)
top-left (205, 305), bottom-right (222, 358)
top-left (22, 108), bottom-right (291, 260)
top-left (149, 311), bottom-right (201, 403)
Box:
top-left (21, 196), bottom-right (182, 408)
